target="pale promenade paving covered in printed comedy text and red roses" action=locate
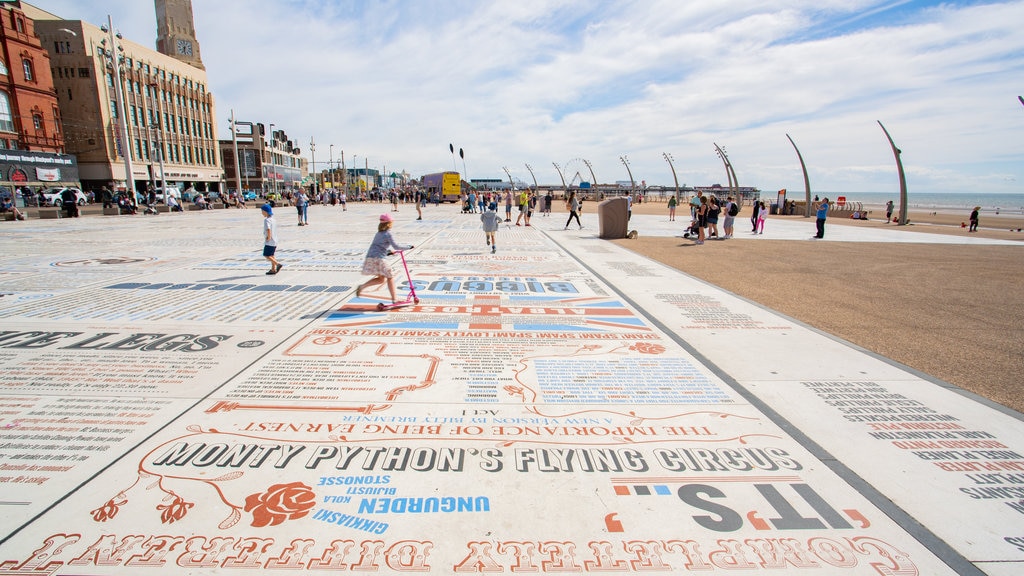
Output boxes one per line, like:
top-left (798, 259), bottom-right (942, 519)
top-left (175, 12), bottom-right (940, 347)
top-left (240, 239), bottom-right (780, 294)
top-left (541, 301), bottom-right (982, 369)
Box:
top-left (0, 204), bottom-right (1024, 576)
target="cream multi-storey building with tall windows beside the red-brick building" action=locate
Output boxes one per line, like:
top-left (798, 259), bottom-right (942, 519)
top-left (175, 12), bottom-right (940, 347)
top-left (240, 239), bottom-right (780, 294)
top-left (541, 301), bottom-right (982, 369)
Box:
top-left (23, 4), bottom-right (223, 192)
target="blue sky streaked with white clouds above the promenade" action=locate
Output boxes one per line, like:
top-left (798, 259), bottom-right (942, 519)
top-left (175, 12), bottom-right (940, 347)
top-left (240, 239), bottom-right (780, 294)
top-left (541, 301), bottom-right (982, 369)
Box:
top-left (32, 0), bottom-right (1024, 195)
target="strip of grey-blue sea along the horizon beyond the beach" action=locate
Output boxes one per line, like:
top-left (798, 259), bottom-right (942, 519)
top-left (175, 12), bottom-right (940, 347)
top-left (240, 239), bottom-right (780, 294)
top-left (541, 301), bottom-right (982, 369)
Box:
top-left (798, 191), bottom-right (1024, 214)
